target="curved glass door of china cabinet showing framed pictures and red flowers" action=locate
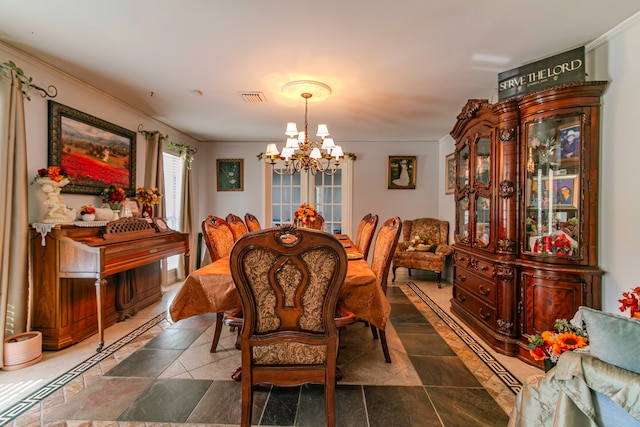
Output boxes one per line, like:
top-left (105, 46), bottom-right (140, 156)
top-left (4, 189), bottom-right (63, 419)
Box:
top-left (523, 116), bottom-right (582, 257)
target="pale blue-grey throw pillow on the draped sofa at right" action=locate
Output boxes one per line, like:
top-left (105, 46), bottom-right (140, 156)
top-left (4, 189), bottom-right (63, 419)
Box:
top-left (579, 307), bottom-right (640, 374)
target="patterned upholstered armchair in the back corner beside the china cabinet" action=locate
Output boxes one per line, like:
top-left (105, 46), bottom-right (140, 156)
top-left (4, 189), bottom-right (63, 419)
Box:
top-left (391, 218), bottom-right (453, 288)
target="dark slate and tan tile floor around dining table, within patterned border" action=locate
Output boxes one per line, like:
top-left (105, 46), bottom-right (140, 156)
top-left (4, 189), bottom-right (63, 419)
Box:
top-left (6, 273), bottom-right (540, 427)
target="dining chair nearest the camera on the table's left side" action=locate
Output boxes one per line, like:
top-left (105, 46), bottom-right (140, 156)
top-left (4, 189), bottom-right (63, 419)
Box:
top-left (202, 215), bottom-right (239, 353)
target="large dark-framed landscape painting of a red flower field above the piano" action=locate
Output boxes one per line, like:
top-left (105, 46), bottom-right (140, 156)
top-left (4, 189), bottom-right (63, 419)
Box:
top-left (49, 100), bottom-right (136, 195)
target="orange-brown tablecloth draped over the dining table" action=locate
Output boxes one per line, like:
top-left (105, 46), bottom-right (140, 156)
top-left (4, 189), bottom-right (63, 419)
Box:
top-left (169, 236), bottom-right (391, 329)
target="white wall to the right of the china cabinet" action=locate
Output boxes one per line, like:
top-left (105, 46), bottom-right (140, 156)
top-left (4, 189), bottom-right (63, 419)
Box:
top-left (587, 14), bottom-right (640, 315)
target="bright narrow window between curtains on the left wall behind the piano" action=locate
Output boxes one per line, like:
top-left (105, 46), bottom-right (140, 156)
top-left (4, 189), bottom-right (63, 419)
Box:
top-left (162, 152), bottom-right (184, 270)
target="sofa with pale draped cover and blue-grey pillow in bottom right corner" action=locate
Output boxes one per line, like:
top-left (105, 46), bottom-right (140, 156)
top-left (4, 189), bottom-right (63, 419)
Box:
top-left (509, 307), bottom-right (640, 427)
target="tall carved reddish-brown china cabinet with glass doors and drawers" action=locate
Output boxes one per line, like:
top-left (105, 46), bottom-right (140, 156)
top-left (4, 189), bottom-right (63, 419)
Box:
top-left (451, 81), bottom-right (607, 363)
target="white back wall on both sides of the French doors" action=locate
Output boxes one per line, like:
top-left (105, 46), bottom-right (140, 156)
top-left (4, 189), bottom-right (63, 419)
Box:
top-left (198, 142), bottom-right (440, 239)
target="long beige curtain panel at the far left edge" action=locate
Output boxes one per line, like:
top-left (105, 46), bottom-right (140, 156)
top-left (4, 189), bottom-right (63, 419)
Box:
top-left (0, 67), bottom-right (29, 363)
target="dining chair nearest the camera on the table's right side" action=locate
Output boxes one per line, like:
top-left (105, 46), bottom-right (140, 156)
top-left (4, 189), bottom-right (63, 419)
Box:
top-left (370, 216), bottom-right (402, 363)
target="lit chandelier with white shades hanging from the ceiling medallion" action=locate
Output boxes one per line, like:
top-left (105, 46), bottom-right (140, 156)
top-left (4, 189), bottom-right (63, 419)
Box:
top-left (265, 80), bottom-right (344, 175)
